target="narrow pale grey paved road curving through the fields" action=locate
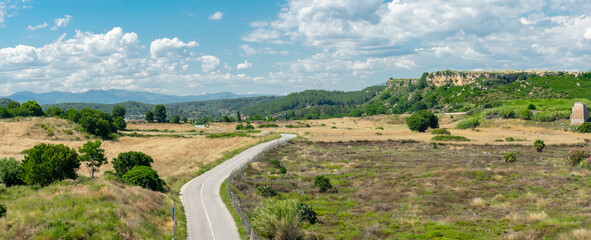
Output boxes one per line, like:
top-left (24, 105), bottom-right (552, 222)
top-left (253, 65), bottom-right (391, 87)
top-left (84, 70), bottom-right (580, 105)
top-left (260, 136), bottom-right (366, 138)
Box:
top-left (181, 134), bottom-right (296, 240)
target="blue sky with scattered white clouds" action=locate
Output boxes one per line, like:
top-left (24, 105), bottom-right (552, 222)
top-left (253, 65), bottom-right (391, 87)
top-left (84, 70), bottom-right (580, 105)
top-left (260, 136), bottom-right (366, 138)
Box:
top-left (0, 0), bottom-right (591, 95)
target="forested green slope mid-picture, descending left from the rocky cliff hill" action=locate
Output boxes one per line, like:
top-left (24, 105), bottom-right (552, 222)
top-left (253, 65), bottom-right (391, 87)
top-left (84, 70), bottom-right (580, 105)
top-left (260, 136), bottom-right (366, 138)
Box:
top-left (242, 86), bottom-right (386, 119)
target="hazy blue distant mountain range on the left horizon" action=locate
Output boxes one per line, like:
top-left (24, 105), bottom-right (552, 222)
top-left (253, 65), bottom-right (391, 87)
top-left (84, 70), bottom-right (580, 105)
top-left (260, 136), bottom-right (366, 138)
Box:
top-left (5, 89), bottom-right (262, 104)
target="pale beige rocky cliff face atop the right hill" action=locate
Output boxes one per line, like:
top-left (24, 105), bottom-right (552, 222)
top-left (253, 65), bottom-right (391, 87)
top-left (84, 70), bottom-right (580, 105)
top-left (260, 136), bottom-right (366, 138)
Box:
top-left (426, 70), bottom-right (582, 87)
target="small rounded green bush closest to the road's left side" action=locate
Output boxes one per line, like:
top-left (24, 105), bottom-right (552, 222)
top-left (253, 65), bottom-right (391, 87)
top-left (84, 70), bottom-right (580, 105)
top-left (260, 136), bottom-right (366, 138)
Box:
top-left (121, 166), bottom-right (164, 192)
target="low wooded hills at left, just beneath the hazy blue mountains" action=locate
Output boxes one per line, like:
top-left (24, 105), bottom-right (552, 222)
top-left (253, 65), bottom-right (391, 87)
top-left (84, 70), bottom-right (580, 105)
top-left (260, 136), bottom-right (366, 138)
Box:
top-left (43, 97), bottom-right (279, 119)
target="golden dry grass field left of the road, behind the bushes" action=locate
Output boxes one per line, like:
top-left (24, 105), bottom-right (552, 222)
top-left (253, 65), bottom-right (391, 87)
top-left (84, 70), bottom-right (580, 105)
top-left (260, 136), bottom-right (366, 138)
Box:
top-left (0, 118), bottom-right (258, 177)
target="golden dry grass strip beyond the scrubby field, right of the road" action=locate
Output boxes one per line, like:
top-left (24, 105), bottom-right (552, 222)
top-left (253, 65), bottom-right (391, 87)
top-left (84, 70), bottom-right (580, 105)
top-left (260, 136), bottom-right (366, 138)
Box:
top-left (205, 115), bottom-right (591, 145)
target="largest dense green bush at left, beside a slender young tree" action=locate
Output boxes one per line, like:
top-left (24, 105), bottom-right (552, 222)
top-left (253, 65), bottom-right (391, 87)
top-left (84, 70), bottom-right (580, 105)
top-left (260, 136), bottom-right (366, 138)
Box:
top-left (18, 143), bottom-right (80, 186)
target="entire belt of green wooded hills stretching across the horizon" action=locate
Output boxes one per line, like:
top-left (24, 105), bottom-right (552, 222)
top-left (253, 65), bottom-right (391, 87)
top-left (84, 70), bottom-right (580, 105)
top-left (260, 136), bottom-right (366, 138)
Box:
top-left (0, 71), bottom-right (591, 123)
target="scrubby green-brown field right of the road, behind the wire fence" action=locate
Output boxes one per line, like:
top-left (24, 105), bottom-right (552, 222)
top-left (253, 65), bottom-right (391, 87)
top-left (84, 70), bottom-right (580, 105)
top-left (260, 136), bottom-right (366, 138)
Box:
top-left (234, 141), bottom-right (591, 239)
